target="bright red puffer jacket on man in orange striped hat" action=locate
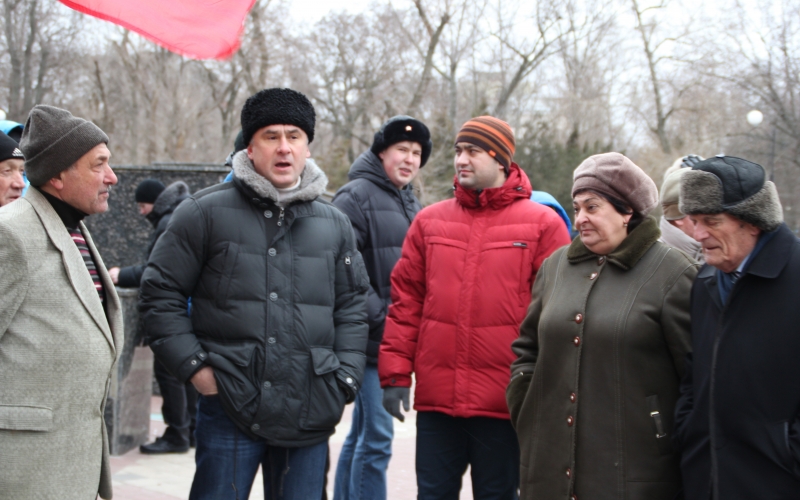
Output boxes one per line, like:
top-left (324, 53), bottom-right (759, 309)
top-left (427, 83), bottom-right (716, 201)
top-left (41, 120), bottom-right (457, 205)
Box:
top-left (378, 163), bottom-right (570, 419)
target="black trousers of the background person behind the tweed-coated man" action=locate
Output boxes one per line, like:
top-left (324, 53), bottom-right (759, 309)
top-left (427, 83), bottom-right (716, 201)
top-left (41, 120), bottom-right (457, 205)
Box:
top-left (153, 360), bottom-right (197, 446)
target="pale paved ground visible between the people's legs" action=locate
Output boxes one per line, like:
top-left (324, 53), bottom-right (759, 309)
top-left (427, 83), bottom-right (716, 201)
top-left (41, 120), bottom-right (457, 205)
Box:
top-left (111, 397), bottom-right (472, 500)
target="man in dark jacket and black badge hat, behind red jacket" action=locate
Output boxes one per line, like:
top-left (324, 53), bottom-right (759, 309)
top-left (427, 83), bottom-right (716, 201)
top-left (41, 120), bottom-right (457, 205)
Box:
top-left (333, 115), bottom-right (433, 500)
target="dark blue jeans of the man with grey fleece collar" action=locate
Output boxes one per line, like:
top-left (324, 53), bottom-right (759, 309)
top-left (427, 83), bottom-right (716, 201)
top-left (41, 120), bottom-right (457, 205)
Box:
top-left (189, 396), bottom-right (328, 500)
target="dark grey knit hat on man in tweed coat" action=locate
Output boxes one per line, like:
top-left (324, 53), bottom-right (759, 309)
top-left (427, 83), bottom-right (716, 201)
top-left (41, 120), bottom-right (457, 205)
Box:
top-left (19, 104), bottom-right (108, 186)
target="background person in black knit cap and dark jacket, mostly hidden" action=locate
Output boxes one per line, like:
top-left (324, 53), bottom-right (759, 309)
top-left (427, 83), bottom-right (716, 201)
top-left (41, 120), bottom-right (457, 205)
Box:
top-left (108, 179), bottom-right (197, 455)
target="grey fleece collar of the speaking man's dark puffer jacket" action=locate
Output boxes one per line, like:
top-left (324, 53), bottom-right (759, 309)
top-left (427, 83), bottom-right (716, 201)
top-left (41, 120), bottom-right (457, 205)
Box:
top-left (233, 150), bottom-right (328, 206)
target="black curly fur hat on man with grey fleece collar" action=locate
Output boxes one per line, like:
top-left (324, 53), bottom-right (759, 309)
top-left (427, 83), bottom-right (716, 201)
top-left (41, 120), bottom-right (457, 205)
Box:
top-left (242, 88), bottom-right (316, 146)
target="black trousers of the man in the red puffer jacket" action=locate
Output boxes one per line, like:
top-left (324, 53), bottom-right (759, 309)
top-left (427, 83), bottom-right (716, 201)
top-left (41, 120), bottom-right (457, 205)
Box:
top-left (416, 412), bottom-right (519, 500)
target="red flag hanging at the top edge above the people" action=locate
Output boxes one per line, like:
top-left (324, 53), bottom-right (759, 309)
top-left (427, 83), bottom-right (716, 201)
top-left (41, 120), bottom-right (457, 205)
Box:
top-left (60, 0), bottom-right (255, 59)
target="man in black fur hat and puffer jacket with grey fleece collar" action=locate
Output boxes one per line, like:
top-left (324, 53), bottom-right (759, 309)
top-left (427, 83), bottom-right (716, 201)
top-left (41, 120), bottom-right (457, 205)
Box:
top-left (140, 89), bottom-right (369, 500)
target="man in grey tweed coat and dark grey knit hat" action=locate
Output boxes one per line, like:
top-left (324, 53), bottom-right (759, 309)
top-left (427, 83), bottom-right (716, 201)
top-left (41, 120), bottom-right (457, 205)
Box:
top-left (0, 105), bottom-right (123, 500)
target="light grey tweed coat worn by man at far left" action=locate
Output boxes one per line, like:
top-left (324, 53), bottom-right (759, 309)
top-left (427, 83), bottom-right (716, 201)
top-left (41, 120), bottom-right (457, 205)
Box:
top-left (0, 189), bottom-right (123, 500)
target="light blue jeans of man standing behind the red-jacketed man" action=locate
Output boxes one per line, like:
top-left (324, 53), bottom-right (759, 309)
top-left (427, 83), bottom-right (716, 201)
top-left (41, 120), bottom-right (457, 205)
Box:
top-left (333, 365), bottom-right (394, 500)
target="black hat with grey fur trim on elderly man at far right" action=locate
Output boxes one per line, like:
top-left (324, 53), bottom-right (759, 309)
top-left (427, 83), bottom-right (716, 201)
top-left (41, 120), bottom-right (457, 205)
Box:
top-left (680, 156), bottom-right (783, 232)
